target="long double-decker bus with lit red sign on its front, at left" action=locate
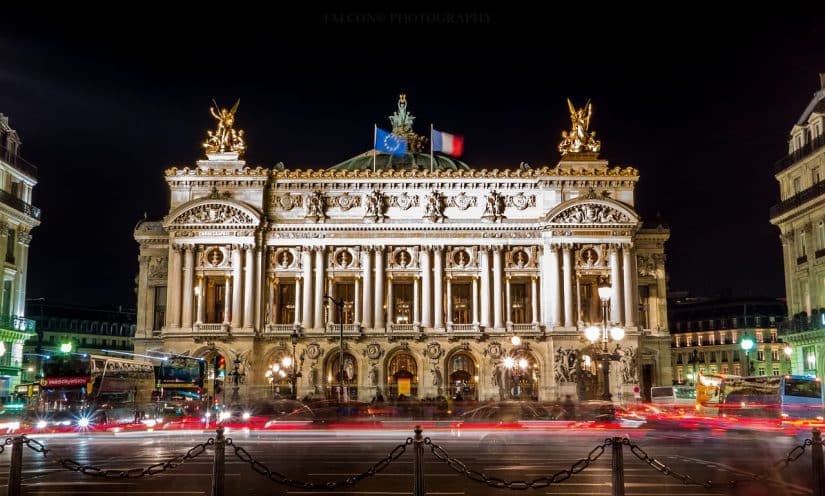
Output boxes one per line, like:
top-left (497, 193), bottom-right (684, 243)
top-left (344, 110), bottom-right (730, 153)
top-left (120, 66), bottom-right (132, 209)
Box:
top-left (37, 353), bottom-right (155, 428)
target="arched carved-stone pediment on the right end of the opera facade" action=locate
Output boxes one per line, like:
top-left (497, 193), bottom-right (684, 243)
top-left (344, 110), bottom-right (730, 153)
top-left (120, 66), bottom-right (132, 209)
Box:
top-left (545, 198), bottom-right (639, 227)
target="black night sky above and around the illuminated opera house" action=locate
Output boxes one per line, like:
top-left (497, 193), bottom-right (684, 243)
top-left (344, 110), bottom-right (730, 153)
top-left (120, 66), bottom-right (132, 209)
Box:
top-left (0, 7), bottom-right (825, 306)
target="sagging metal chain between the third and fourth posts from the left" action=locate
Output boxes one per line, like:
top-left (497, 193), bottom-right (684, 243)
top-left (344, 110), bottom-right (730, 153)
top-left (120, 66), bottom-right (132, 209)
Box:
top-left (424, 437), bottom-right (613, 490)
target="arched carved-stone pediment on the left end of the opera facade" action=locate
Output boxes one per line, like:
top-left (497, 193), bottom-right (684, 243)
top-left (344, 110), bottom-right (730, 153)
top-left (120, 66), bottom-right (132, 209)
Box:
top-left (163, 198), bottom-right (261, 229)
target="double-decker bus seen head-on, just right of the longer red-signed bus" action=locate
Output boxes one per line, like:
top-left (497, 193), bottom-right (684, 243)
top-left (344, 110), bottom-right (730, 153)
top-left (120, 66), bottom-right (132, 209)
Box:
top-left (154, 356), bottom-right (207, 418)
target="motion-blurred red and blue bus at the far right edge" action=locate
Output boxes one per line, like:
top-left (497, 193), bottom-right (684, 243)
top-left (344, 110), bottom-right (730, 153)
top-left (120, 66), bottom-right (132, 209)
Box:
top-left (719, 375), bottom-right (825, 420)
